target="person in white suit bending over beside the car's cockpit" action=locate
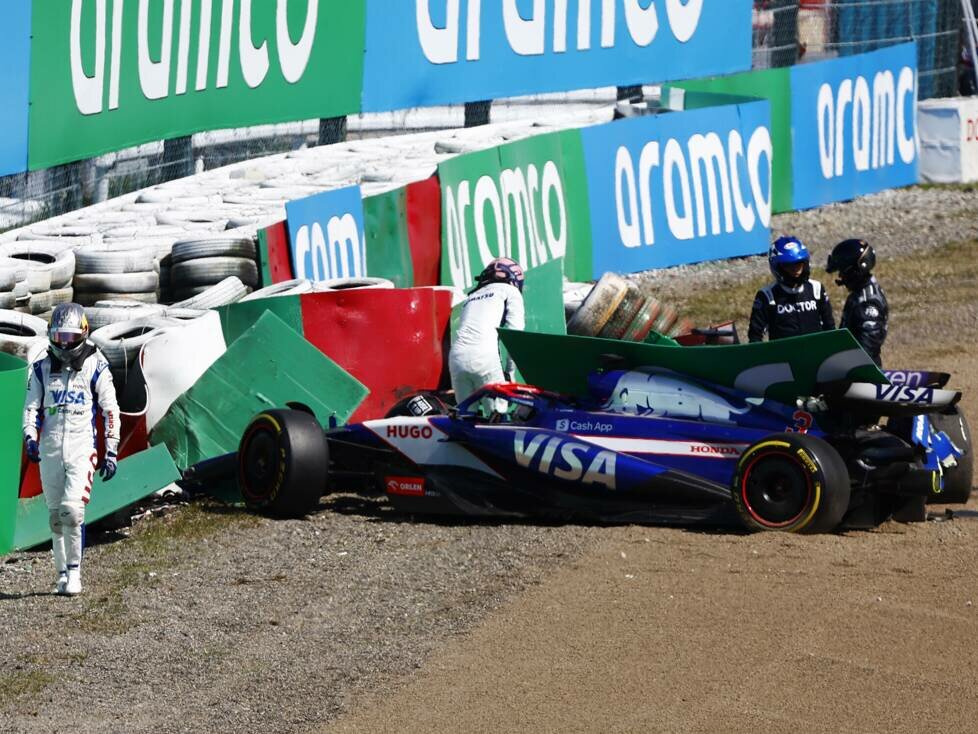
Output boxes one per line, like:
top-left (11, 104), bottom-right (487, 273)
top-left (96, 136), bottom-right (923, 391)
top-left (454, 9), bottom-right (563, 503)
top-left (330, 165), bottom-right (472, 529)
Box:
top-left (448, 257), bottom-right (525, 403)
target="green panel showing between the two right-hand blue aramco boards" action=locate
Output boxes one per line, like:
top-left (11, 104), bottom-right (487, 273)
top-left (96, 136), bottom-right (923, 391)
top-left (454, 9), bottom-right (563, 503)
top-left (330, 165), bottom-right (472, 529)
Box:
top-left (663, 68), bottom-right (794, 213)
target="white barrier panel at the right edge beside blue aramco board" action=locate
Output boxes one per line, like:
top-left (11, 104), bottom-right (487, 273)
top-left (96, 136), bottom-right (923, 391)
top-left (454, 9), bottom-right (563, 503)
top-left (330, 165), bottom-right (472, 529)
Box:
top-left (917, 97), bottom-right (978, 183)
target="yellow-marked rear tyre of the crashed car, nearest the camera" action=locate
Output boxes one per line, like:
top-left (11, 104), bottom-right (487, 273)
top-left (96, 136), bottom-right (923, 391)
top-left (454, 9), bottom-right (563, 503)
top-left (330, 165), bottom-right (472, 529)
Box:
top-left (731, 433), bottom-right (850, 533)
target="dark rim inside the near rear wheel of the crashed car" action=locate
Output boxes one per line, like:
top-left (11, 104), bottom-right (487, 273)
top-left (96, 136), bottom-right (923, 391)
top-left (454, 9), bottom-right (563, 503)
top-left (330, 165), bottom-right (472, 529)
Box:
top-left (740, 452), bottom-right (814, 529)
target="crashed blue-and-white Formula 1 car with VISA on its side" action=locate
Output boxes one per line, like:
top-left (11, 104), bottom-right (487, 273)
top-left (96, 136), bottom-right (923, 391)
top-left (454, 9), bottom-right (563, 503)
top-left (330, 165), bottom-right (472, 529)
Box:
top-left (238, 337), bottom-right (973, 533)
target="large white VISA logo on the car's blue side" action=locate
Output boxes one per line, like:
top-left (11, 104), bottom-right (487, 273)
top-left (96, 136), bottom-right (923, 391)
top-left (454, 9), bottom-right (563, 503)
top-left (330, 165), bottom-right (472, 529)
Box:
top-left (513, 431), bottom-right (616, 489)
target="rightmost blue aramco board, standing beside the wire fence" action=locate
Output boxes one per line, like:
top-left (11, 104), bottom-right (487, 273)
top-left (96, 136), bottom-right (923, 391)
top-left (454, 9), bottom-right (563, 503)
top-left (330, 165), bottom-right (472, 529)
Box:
top-left (791, 43), bottom-right (919, 209)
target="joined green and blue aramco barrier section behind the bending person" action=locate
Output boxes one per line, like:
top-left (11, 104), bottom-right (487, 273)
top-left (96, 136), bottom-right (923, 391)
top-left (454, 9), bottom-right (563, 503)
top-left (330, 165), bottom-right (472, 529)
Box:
top-left (438, 100), bottom-right (772, 288)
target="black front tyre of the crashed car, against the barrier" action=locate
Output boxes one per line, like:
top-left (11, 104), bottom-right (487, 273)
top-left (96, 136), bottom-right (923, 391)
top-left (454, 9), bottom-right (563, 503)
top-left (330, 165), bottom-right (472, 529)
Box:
top-left (238, 410), bottom-right (329, 518)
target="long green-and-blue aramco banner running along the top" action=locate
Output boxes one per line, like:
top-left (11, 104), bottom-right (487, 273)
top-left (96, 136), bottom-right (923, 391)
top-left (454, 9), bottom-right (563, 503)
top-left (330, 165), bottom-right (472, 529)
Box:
top-left (11, 0), bottom-right (752, 172)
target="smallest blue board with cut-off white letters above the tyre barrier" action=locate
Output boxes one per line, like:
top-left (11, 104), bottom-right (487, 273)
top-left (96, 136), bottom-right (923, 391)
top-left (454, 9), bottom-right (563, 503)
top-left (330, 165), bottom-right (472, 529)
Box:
top-left (285, 186), bottom-right (367, 280)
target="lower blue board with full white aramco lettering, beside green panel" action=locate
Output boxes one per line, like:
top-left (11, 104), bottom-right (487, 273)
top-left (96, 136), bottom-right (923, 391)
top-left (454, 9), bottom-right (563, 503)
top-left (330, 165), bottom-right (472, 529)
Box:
top-left (581, 100), bottom-right (773, 273)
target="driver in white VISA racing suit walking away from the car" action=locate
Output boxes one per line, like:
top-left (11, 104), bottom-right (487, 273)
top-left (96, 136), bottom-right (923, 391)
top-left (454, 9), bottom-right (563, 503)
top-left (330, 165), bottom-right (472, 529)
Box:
top-left (24, 303), bottom-right (119, 596)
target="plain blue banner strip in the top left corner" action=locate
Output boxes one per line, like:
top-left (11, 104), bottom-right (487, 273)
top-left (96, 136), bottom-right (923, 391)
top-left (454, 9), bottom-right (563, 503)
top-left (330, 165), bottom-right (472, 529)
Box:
top-left (0, 0), bottom-right (31, 176)
